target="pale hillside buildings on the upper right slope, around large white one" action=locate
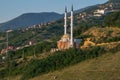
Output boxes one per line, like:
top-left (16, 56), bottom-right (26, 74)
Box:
top-left (77, 3), bottom-right (120, 20)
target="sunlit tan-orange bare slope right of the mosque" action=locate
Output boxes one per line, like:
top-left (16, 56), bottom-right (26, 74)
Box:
top-left (82, 27), bottom-right (120, 43)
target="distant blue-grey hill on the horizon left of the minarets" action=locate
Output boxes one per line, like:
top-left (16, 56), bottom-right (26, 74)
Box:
top-left (0, 12), bottom-right (63, 30)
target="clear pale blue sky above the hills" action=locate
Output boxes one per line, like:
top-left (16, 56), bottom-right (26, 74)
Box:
top-left (0, 0), bottom-right (108, 23)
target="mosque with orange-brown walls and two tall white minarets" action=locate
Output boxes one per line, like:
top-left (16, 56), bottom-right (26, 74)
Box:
top-left (57, 6), bottom-right (81, 50)
